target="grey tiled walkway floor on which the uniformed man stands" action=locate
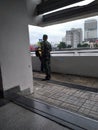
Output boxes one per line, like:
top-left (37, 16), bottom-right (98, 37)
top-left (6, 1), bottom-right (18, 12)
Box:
top-left (29, 73), bottom-right (98, 120)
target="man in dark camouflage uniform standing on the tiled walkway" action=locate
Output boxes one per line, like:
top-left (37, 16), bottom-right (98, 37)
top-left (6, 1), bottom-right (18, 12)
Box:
top-left (41, 34), bottom-right (52, 80)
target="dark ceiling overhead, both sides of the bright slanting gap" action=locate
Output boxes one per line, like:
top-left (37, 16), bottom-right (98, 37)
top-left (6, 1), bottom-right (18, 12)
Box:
top-left (36, 0), bottom-right (98, 25)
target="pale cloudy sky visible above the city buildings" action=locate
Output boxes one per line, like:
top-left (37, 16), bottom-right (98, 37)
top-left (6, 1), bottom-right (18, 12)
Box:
top-left (28, 0), bottom-right (98, 44)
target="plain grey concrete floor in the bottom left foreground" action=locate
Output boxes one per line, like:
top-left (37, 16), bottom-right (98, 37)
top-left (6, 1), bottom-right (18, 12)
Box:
top-left (0, 103), bottom-right (70, 130)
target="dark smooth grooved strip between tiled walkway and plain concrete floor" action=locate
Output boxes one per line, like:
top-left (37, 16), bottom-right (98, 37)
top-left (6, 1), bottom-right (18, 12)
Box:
top-left (5, 93), bottom-right (98, 130)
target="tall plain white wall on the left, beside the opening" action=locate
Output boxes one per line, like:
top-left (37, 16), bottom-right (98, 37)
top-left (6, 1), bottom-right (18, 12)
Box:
top-left (0, 0), bottom-right (38, 92)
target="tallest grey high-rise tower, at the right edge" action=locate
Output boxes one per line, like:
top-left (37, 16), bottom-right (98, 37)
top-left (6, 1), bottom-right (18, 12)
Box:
top-left (84, 19), bottom-right (98, 42)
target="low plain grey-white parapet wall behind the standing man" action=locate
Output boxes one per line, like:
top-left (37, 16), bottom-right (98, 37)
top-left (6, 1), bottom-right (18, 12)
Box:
top-left (32, 56), bottom-right (98, 78)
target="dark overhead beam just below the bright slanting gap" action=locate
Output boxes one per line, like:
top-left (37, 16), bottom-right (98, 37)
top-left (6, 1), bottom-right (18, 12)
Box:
top-left (43, 2), bottom-right (98, 23)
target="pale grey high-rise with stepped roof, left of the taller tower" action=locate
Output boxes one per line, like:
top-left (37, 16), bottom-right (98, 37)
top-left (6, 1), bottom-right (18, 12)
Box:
top-left (66, 28), bottom-right (83, 48)
